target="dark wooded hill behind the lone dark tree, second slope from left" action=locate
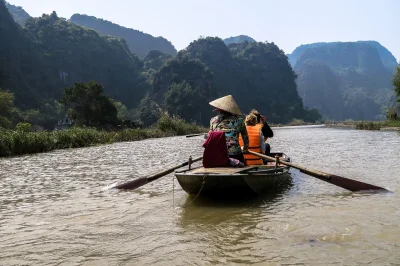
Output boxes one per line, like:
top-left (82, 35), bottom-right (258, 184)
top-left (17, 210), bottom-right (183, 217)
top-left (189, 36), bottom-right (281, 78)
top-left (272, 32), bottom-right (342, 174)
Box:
top-left (26, 12), bottom-right (147, 107)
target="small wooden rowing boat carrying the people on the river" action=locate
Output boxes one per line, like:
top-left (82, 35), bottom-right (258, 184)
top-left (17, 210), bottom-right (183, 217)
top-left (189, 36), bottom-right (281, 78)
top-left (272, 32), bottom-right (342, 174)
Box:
top-left (175, 153), bottom-right (291, 196)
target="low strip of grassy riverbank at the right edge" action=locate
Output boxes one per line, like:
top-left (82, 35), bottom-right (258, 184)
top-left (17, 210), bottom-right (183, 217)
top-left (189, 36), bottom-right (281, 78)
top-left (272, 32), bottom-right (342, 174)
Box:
top-left (326, 120), bottom-right (400, 131)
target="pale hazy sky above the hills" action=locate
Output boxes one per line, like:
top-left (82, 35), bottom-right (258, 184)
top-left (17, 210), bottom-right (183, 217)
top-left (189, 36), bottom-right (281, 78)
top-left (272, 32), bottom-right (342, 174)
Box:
top-left (7, 0), bottom-right (400, 61)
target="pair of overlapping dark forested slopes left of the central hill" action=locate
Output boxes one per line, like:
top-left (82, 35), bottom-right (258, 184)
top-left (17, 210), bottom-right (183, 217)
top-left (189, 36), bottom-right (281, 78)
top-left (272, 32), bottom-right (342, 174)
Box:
top-left (0, 1), bottom-right (149, 111)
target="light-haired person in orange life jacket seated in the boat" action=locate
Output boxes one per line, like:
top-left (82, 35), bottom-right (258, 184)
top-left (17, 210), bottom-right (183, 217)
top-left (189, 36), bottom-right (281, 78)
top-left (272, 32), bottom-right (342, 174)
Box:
top-left (239, 113), bottom-right (265, 165)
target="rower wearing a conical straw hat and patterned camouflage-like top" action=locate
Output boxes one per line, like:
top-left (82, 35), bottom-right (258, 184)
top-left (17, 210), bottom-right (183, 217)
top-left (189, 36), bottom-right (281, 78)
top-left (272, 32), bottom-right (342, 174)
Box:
top-left (209, 95), bottom-right (249, 163)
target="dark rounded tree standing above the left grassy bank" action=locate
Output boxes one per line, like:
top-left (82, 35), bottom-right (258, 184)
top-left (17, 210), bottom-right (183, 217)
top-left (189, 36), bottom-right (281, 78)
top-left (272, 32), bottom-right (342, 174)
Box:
top-left (60, 81), bottom-right (120, 127)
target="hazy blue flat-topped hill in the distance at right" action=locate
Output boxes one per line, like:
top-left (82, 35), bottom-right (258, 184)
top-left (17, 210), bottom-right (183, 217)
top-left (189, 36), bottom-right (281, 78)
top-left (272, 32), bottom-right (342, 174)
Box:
top-left (288, 41), bottom-right (397, 120)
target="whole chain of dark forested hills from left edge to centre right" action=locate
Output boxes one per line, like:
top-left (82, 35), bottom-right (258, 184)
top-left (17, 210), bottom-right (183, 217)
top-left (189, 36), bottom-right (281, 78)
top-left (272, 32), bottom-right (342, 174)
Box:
top-left (0, 2), bottom-right (320, 128)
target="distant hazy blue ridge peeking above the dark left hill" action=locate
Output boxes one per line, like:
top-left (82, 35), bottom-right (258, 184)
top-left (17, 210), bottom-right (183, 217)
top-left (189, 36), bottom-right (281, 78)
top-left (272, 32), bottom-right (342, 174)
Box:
top-left (70, 14), bottom-right (177, 58)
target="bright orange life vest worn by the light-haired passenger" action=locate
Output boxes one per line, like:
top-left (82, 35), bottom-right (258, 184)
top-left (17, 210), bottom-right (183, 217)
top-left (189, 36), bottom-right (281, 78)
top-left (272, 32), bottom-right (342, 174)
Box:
top-left (239, 124), bottom-right (263, 165)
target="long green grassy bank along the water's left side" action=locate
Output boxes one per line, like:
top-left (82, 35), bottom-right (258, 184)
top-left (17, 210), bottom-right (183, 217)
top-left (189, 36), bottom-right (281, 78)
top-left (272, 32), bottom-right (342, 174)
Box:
top-left (0, 116), bottom-right (207, 157)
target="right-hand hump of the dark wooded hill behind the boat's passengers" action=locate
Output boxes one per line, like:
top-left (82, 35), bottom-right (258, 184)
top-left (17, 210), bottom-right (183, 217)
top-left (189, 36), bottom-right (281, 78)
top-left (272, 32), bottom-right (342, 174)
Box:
top-left (230, 42), bottom-right (310, 122)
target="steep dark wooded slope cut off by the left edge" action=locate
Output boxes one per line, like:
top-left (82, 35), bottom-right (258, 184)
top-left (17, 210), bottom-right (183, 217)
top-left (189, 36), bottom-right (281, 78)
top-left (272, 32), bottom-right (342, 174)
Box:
top-left (0, 1), bottom-right (53, 107)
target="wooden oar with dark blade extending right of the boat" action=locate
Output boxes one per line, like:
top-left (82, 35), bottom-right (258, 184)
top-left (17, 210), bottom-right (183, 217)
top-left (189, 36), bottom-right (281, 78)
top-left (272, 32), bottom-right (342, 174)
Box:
top-left (249, 151), bottom-right (388, 191)
